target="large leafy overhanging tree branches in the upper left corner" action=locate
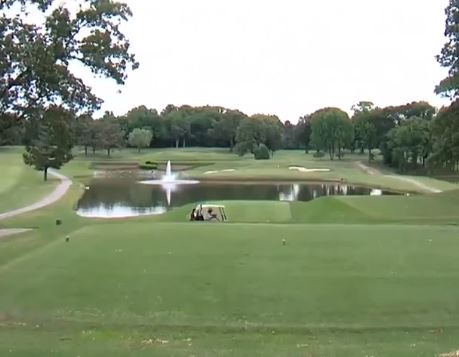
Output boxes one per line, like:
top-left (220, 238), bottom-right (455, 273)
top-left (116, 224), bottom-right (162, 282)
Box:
top-left (0, 0), bottom-right (138, 117)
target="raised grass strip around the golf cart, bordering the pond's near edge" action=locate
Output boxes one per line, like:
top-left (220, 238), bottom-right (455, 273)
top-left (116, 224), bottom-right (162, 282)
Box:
top-left (145, 190), bottom-right (459, 225)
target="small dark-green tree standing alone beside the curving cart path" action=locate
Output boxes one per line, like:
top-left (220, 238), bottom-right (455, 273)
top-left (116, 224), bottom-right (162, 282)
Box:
top-left (23, 106), bottom-right (74, 181)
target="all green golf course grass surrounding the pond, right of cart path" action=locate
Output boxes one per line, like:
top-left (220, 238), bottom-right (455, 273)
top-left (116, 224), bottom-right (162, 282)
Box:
top-left (0, 149), bottom-right (459, 357)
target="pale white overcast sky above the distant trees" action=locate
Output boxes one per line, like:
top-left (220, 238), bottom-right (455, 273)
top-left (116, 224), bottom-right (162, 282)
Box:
top-left (84, 0), bottom-right (448, 122)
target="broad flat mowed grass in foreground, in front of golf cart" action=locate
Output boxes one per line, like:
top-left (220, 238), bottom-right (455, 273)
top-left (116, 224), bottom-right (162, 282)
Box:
top-left (0, 222), bottom-right (459, 356)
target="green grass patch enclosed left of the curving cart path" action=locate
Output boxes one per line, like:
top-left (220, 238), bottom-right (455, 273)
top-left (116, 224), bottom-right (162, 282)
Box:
top-left (0, 148), bottom-right (57, 213)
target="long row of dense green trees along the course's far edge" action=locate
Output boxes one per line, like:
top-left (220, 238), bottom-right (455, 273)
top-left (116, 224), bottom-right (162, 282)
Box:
top-left (0, 98), bottom-right (452, 171)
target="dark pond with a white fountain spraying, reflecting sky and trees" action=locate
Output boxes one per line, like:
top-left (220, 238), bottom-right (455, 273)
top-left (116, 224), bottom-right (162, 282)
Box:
top-left (77, 178), bottom-right (394, 218)
